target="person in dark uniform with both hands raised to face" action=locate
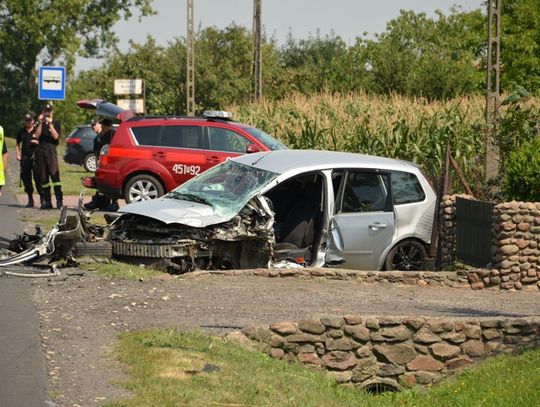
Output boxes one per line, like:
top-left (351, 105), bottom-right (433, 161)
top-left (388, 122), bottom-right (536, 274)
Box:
top-left (34, 104), bottom-right (63, 209)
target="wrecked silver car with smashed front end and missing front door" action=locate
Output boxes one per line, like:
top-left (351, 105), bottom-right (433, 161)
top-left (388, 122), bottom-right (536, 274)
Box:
top-left (105, 150), bottom-right (436, 272)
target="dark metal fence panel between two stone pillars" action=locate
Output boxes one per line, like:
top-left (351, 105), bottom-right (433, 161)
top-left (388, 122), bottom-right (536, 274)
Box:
top-left (456, 197), bottom-right (495, 267)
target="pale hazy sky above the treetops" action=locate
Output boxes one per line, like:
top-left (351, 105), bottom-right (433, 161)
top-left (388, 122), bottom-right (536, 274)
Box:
top-left (77, 0), bottom-right (484, 70)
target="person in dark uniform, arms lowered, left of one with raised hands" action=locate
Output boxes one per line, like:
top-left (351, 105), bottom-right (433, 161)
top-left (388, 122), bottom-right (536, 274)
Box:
top-left (15, 114), bottom-right (43, 208)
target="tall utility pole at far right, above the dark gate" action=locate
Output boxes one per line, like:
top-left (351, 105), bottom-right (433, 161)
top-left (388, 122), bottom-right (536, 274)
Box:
top-left (485, 0), bottom-right (502, 181)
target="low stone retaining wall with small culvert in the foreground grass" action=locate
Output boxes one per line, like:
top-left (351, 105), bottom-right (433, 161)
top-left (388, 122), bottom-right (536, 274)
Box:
top-left (242, 315), bottom-right (540, 389)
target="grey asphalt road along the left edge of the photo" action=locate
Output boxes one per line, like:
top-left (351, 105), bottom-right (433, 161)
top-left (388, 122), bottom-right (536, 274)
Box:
top-left (0, 188), bottom-right (48, 407)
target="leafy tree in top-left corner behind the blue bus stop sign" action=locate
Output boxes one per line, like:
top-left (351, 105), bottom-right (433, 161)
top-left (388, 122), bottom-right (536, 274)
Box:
top-left (0, 0), bottom-right (153, 133)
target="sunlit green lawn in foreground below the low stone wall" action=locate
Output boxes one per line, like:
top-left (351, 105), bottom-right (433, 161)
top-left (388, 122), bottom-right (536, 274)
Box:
top-left (107, 330), bottom-right (540, 407)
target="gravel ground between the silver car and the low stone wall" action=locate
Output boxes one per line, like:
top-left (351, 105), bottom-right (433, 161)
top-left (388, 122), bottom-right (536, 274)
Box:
top-left (34, 273), bottom-right (540, 406)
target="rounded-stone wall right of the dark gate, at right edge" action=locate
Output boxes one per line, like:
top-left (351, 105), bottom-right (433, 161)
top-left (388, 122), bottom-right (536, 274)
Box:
top-left (492, 201), bottom-right (540, 290)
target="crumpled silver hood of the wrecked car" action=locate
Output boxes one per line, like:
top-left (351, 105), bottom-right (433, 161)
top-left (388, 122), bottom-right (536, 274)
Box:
top-left (119, 197), bottom-right (229, 228)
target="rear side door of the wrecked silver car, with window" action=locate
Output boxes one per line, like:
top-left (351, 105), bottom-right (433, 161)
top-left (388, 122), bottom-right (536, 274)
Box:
top-left (326, 169), bottom-right (396, 270)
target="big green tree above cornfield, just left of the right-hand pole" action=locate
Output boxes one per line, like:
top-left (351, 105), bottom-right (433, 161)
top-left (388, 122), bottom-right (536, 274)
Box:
top-left (364, 9), bottom-right (485, 99)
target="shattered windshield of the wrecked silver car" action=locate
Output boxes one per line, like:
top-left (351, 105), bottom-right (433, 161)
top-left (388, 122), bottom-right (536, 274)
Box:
top-left (167, 160), bottom-right (278, 219)
